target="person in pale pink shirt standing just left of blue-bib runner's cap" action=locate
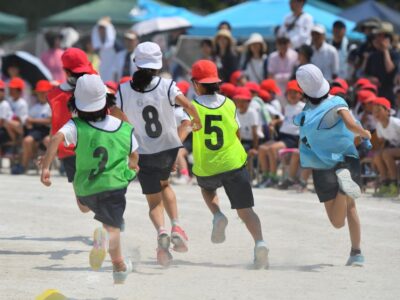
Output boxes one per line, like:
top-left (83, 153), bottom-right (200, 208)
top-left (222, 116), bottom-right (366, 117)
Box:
top-left (268, 36), bottom-right (298, 99)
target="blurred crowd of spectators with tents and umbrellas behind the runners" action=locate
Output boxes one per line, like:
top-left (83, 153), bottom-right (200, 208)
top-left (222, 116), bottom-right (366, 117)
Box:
top-left (0, 0), bottom-right (400, 197)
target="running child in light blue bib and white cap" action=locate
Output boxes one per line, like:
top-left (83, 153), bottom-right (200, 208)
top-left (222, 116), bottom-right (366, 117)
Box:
top-left (294, 64), bottom-right (371, 266)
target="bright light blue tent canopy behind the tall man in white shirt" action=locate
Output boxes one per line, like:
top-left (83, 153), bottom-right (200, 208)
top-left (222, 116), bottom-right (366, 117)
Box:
top-left (189, 0), bottom-right (363, 39)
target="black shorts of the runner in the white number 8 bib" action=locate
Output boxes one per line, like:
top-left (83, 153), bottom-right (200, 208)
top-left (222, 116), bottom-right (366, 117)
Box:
top-left (138, 148), bottom-right (179, 195)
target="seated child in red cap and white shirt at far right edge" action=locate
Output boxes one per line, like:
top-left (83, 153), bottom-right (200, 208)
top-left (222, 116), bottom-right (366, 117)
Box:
top-left (372, 98), bottom-right (400, 197)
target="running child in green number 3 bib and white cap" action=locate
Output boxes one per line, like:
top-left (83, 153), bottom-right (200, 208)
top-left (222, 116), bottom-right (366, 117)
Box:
top-left (41, 75), bottom-right (138, 284)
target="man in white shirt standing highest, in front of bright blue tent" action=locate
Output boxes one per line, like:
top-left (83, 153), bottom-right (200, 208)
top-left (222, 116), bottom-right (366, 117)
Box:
top-left (278, 0), bottom-right (314, 49)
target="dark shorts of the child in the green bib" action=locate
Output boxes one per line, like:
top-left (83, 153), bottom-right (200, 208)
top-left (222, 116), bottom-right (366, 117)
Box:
top-left (79, 188), bottom-right (126, 229)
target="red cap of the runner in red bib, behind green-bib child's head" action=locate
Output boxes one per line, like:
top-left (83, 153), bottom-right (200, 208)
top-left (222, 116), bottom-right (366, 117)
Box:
top-left (61, 48), bottom-right (97, 74)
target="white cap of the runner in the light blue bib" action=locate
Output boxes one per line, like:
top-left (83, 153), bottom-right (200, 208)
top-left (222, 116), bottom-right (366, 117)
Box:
top-left (296, 64), bottom-right (330, 98)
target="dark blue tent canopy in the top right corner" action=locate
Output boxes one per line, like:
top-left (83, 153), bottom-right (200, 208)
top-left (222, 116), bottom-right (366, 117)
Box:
top-left (340, 0), bottom-right (400, 32)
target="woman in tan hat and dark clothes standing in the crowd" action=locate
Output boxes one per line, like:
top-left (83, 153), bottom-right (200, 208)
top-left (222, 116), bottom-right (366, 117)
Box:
top-left (214, 29), bottom-right (238, 82)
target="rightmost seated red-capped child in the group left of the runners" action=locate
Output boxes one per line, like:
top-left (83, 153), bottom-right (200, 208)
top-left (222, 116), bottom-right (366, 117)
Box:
top-left (11, 80), bottom-right (53, 175)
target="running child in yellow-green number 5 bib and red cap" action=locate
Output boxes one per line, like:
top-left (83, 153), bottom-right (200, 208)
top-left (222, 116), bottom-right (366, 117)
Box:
top-left (192, 60), bottom-right (268, 268)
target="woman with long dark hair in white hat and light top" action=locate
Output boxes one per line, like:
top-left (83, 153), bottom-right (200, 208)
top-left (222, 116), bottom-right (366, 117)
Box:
top-left (242, 33), bottom-right (268, 83)
